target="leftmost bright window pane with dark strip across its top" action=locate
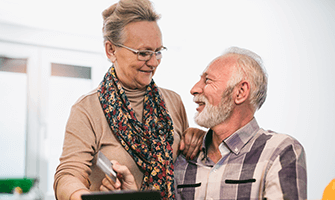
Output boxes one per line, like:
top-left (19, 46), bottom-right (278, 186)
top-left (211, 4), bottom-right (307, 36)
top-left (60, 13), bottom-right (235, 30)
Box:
top-left (0, 56), bottom-right (27, 178)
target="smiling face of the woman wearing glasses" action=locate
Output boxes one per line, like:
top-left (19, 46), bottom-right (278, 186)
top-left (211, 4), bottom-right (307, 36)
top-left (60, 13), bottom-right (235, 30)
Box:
top-left (108, 21), bottom-right (162, 89)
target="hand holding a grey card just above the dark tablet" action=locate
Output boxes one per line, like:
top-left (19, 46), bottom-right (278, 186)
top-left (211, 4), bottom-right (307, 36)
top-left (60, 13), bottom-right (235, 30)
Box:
top-left (100, 160), bottom-right (138, 191)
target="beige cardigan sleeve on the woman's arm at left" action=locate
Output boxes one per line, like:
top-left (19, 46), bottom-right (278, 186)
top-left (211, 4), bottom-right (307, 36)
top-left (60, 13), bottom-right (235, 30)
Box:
top-left (54, 95), bottom-right (97, 200)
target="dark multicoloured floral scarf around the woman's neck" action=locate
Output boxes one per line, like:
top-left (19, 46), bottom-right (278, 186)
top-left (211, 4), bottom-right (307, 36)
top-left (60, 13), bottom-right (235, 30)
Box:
top-left (98, 66), bottom-right (175, 199)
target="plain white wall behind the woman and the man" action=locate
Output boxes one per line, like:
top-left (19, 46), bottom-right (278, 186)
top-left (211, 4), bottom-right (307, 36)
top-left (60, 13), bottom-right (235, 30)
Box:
top-left (0, 0), bottom-right (335, 199)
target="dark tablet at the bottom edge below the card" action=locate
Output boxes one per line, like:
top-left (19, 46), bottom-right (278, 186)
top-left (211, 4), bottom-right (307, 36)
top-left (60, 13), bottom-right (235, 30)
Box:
top-left (81, 190), bottom-right (161, 200)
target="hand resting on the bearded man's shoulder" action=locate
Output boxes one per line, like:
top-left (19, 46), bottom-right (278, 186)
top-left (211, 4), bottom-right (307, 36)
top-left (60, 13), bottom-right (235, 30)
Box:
top-left (179, 128), bottom-right (206, 159)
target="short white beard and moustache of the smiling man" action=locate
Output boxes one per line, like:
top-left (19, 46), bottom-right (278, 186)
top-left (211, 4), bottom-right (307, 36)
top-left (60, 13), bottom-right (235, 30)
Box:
top-left (193, 90), bottom-right (234, 128)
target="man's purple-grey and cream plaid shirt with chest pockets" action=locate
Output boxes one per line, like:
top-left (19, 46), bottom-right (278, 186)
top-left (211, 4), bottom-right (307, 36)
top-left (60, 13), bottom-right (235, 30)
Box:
top-left (175, 119), bottom-right (307, 200)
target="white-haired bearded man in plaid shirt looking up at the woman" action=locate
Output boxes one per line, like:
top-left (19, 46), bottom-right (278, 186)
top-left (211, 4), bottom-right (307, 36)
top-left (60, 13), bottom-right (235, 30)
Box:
top-left (175, 47), bottom-right (307, 200)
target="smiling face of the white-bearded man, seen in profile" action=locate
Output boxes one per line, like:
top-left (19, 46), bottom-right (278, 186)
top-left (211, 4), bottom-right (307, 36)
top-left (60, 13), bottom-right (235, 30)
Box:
top-left (191, 56), bottom-right (236, 128)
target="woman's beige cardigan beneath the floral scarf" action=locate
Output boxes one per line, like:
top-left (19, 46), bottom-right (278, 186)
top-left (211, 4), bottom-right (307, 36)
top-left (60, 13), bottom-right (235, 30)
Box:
top-left (54, 88), bottom-right (188, 199)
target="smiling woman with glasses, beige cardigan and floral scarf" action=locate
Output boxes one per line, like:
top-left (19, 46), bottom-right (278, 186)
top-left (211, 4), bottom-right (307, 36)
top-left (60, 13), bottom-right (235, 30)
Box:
top-left (54, 0), bottom-right (202, 200)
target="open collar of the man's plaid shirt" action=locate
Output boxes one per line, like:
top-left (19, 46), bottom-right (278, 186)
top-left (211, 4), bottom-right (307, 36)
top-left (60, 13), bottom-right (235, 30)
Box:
top-left (202, 118), bottom-right (259, 157)
